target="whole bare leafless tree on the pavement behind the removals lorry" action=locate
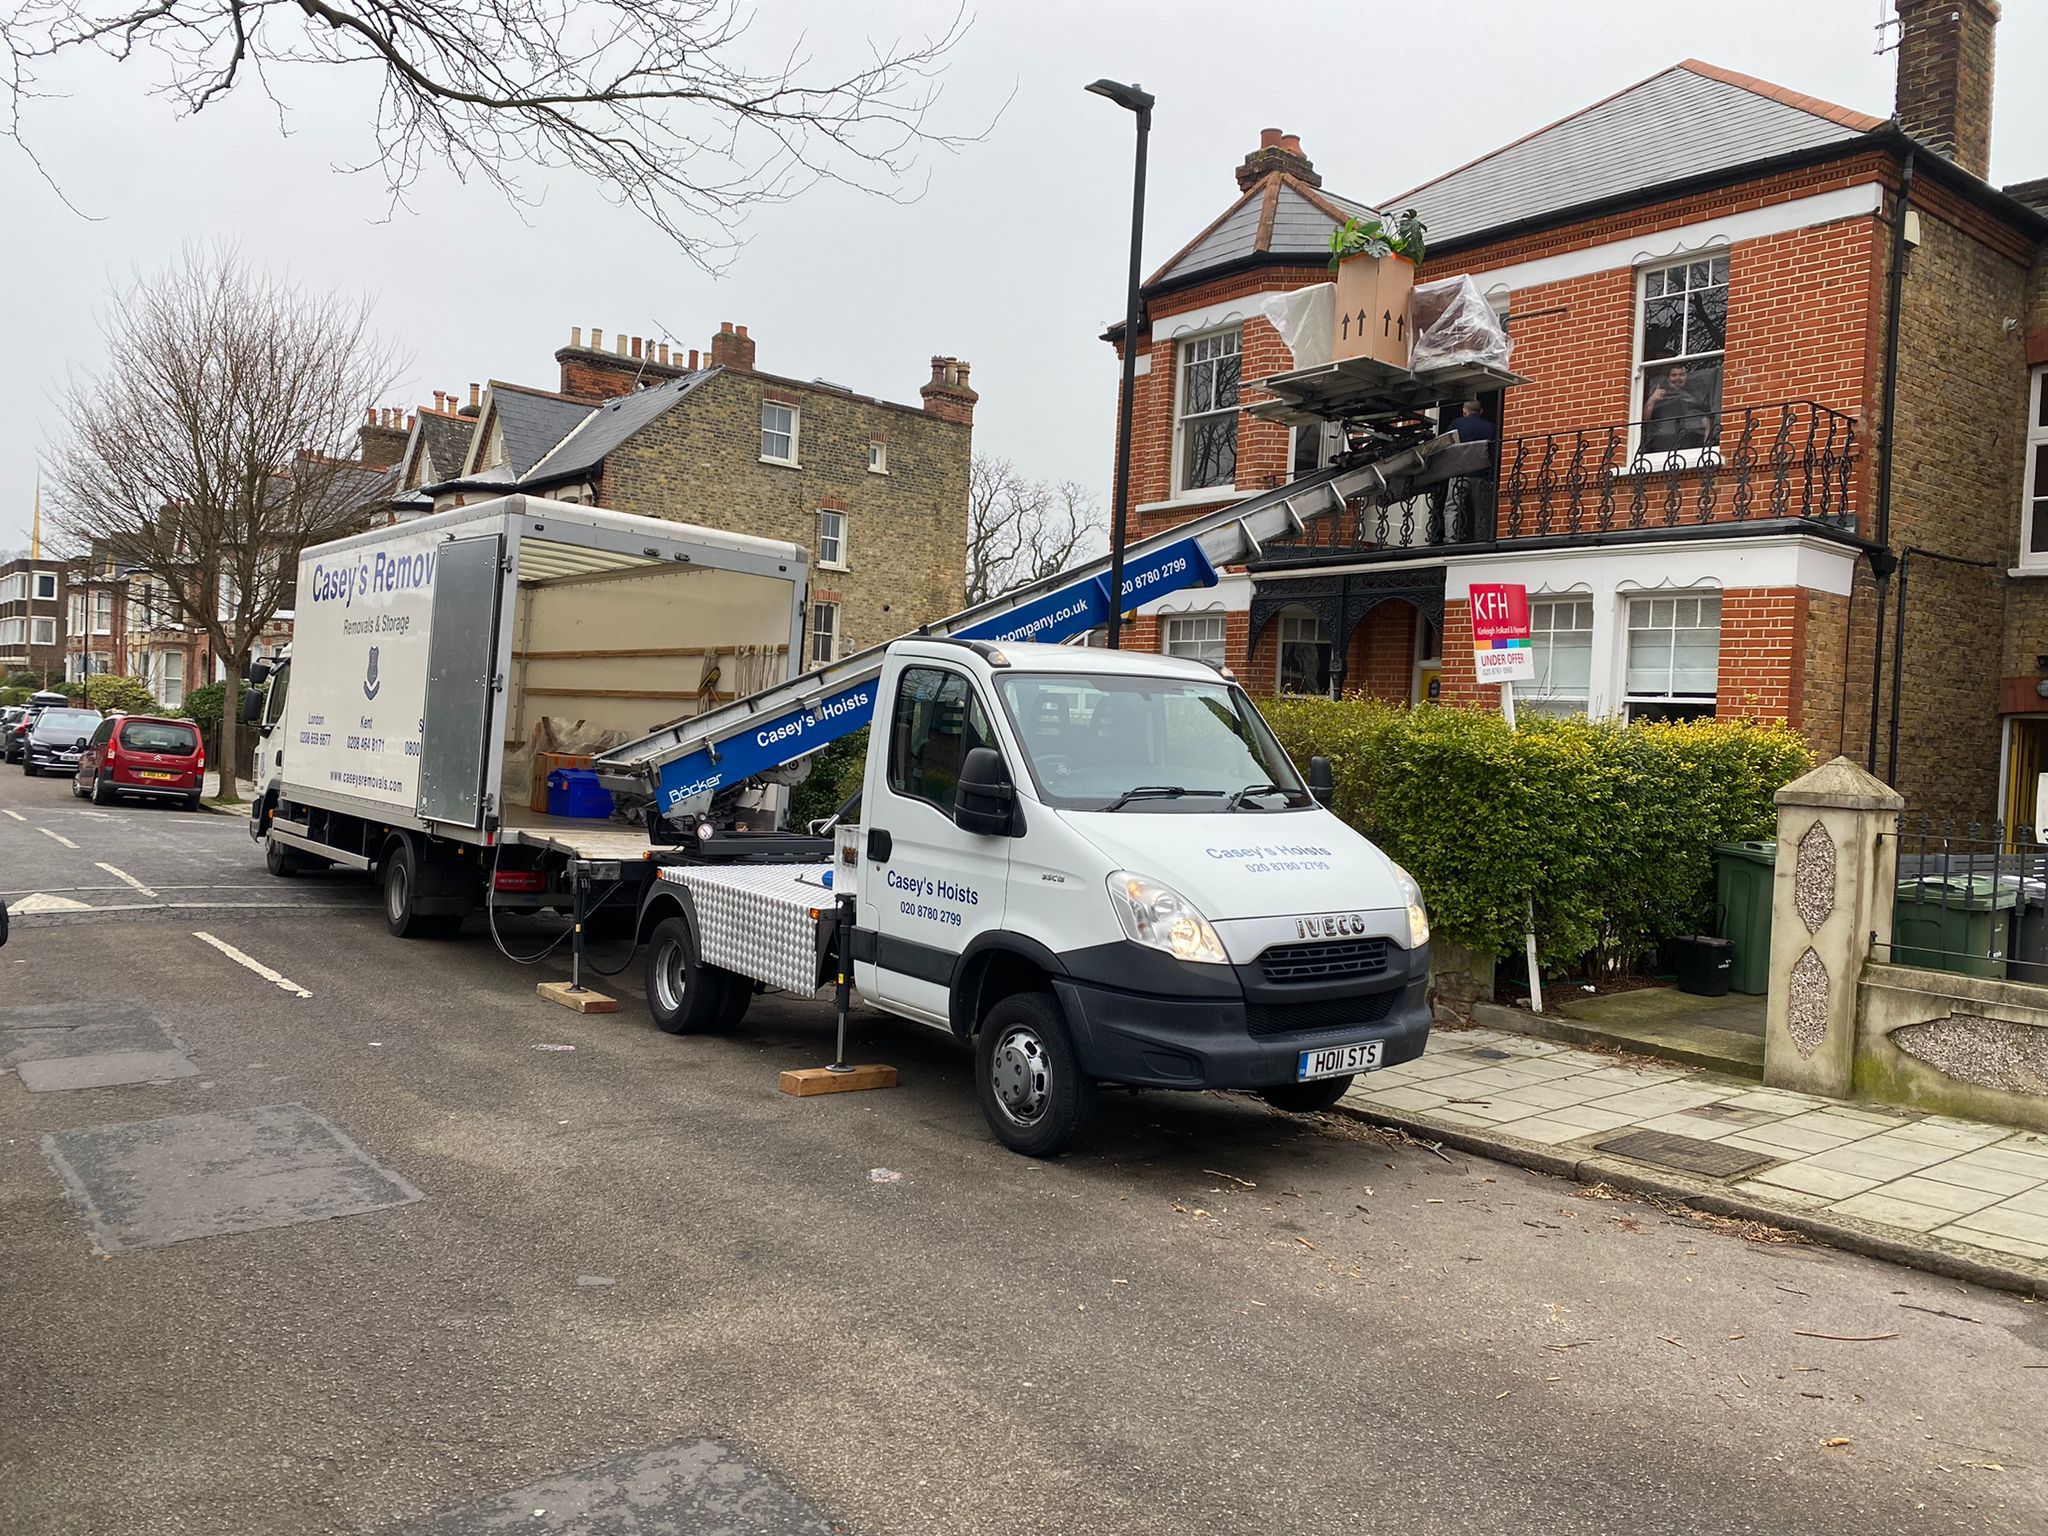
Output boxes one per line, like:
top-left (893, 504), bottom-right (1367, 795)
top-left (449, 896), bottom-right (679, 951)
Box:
top-left (47, 250), bottom-right (399, 799)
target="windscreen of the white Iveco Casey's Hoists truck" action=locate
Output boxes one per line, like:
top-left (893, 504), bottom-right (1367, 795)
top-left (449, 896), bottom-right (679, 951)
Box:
top-left (997, 672), bottom-right (1311, 811)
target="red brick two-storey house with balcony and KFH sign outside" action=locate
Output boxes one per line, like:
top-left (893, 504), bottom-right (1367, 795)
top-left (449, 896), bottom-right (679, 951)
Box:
top-left (1110, 0), bottom-right (2048, 819)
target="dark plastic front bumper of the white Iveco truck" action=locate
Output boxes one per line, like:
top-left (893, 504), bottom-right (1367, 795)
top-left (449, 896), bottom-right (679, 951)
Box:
top-left (1053, 950), bottom-right (1430, 1087)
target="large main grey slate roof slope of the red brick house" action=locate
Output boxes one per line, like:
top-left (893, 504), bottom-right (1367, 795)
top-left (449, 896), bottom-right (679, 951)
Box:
top-left (1386, 59), bottom-right (1884, 246)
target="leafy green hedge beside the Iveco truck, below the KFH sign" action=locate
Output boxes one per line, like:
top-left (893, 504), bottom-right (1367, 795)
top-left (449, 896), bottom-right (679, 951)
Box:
top-left (1262, 698), bottom-right (1812, 971)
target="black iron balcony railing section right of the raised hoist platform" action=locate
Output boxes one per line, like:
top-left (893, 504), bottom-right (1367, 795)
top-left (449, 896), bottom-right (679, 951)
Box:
top-left (1497, 399), bottom-right (1858, 539)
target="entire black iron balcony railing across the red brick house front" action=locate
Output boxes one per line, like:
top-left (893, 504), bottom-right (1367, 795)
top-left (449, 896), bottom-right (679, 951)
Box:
top-left (1262, 399), bottom-right (1858, 565)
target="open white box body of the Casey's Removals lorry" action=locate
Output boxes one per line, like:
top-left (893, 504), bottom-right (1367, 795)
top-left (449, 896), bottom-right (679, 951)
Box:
top-left (281, 496), bottom-right (807, 858)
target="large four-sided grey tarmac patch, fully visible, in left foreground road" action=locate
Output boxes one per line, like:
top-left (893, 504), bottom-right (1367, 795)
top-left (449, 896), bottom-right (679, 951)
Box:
top-left (43, 1104), bottom-right (422, 1253)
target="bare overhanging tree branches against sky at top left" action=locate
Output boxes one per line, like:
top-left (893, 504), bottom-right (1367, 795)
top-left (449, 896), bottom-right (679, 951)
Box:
top-left (0, 0), bottom-right (987, 270)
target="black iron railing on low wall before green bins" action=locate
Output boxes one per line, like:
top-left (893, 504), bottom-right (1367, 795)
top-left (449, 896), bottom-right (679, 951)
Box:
top-left (1874, 815), bottom-right (2048, 983)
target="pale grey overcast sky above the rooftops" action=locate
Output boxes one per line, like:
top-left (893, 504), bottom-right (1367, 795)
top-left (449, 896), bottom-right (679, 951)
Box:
top-left (0, 0), bottom-right (2048, 547)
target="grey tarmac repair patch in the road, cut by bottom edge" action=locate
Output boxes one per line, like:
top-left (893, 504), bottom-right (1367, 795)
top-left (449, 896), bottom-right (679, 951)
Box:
top-left (391, 1440), bottom-right (846, 1536)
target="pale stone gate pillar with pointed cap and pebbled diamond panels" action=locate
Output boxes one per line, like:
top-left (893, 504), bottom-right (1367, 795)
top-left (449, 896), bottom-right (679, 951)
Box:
top-left (1763, 758), bottom-right (1905, 1098)
